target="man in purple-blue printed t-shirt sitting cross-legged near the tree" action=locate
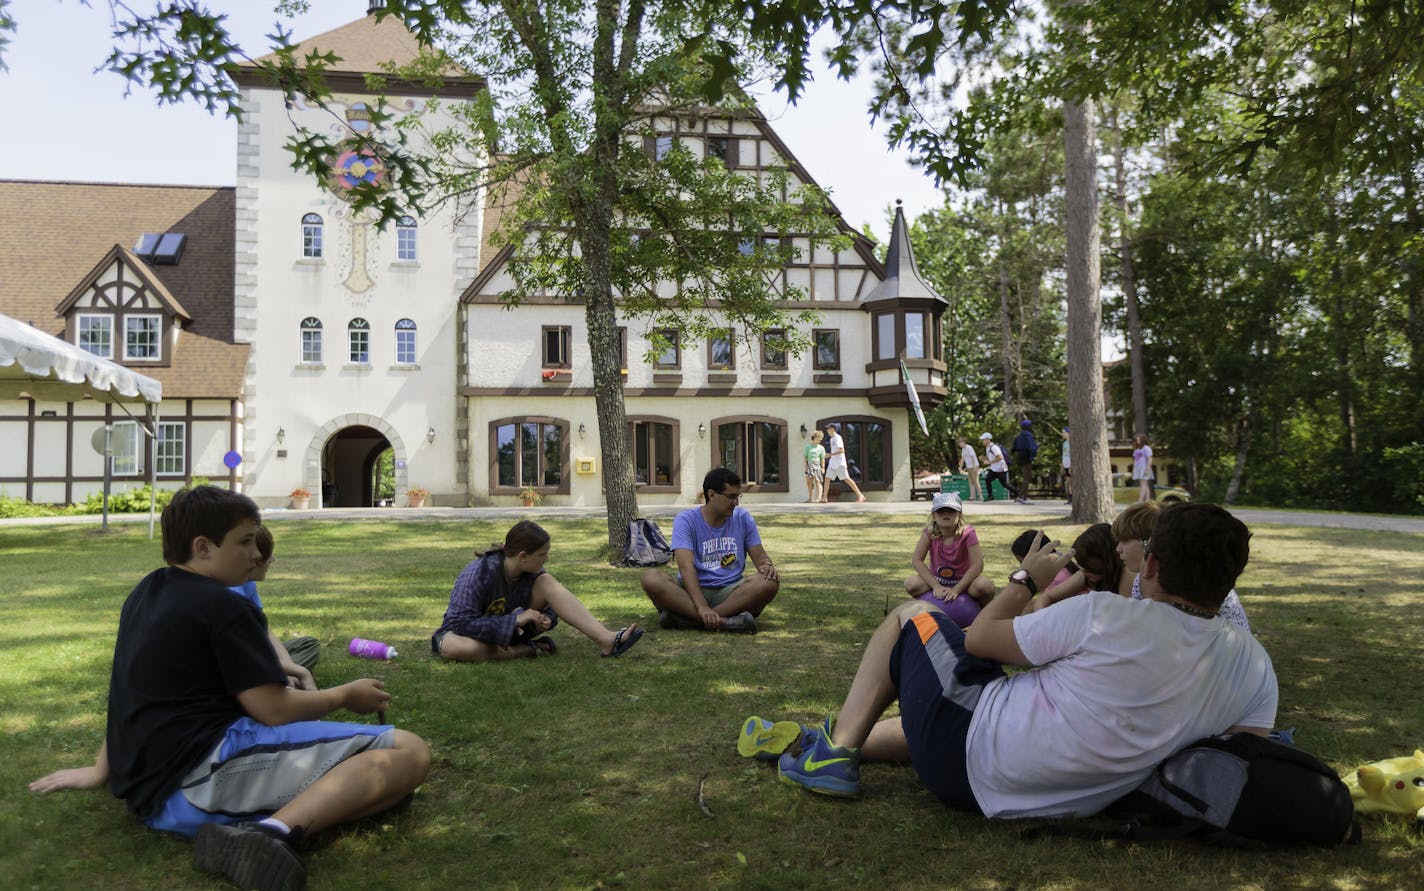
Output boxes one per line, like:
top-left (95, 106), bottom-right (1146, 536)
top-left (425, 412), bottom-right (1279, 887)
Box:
top-left (642, 467), bottom-right (782, 633)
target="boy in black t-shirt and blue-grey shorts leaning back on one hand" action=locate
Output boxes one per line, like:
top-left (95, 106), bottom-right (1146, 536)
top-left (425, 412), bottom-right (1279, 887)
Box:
top-left (30, 485), bottom-right (430, 891)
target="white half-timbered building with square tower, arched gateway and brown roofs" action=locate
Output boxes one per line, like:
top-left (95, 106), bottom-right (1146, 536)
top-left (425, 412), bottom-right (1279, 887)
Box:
top-left (8, 5), bottom-right (946, 507)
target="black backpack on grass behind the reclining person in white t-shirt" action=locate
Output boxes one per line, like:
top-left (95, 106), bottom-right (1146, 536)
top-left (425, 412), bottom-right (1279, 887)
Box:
top-left (1028, 733), bottom-right (1360, 847)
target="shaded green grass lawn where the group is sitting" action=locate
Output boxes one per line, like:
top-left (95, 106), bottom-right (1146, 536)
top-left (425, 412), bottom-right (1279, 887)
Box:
top-left (0, 510), bottom-right (1424, 891)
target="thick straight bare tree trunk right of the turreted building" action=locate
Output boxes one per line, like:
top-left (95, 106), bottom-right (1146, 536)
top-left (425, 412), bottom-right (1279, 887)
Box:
top-left (1064, 93), bottom-right (1114, 522)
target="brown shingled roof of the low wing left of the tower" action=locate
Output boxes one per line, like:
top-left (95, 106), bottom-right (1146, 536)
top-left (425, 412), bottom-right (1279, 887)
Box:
top-left (0, 179), bottom-right (249, 399)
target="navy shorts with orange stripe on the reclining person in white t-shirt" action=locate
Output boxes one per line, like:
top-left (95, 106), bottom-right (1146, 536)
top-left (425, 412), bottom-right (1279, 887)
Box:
top-left (890, 611), bottom-right (1004, 813)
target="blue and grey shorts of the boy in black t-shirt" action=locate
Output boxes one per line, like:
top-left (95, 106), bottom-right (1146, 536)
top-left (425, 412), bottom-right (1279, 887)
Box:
top-left (147, 717), bottom-right (394, 835)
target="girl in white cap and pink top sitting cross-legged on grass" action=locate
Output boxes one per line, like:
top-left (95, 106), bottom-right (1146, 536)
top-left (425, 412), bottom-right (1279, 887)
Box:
top-left (904, 492), bottom-right (994, 628)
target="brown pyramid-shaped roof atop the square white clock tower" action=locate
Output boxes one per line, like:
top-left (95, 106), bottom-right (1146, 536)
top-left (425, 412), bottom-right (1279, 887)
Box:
top-left (234, 14), bottom-right (484, 95)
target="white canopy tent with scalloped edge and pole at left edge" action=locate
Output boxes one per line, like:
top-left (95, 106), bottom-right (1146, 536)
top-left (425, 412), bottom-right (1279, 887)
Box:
top-left (0, 308), bottom-right (164, 529)
